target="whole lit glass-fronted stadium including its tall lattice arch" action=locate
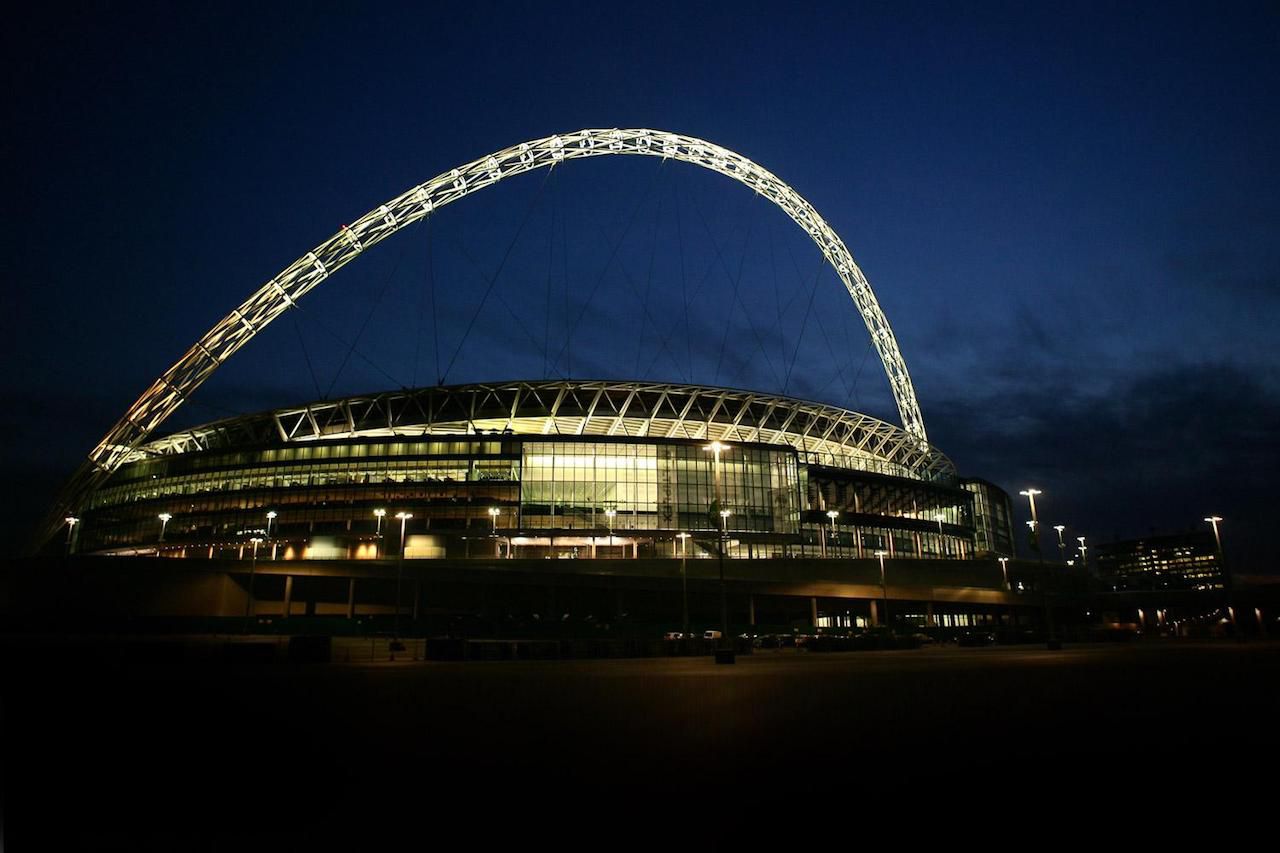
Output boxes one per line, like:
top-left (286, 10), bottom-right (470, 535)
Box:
top-left (45, 129), bottom-right (1041, 631)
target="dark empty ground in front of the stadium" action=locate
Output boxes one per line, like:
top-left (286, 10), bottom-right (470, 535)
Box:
top-left (3, 642), bottom-right (1280, 849)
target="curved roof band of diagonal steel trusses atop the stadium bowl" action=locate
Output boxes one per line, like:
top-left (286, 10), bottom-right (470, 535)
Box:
top-left (124, 379), bottom-right (955, 482)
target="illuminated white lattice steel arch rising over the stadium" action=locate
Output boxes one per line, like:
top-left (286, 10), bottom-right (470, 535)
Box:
top-left (49, 128), bottom-right (928, 532)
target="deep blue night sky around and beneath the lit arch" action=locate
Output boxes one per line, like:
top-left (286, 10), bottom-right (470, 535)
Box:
top-left (0, 3), bottom-right (1280, 563)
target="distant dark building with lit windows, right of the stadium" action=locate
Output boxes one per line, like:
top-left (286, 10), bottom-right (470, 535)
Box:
top-left (1093, 530), bottom-right (1222, 592)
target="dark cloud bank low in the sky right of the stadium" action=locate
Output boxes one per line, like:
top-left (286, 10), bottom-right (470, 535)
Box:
top-left (928, 364), bottom-right (1280, 566)
